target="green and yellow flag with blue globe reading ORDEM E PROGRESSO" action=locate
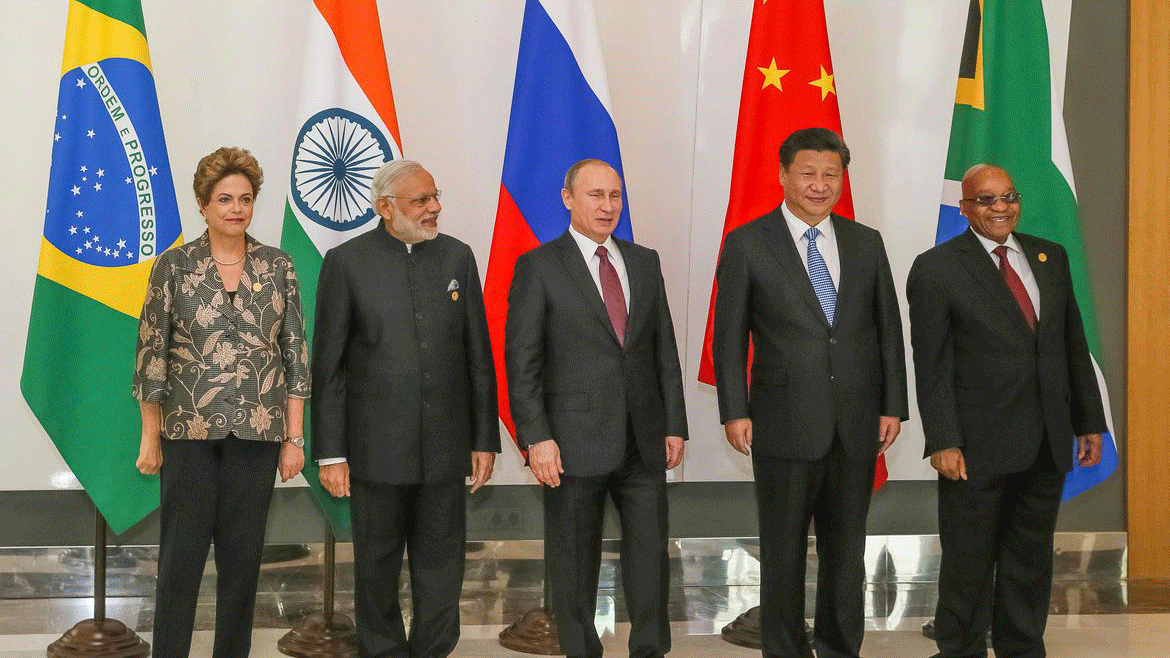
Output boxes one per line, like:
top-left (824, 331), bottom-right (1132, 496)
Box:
top-left (20, 0), bottom-right (183, 533)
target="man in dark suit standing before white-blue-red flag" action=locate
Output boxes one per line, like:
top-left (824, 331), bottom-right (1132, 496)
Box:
top-left (504, 159), bottom-right (687, 658)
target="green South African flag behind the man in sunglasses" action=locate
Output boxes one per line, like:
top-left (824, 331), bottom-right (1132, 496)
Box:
top-left (935, 0), bottom-right (1117, 500)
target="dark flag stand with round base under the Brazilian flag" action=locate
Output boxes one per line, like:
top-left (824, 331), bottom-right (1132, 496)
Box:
top-left (48, 512), bottom-right (150, 658)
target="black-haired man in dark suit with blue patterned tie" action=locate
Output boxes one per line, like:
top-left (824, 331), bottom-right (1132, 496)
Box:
top-left (713, 128), bottom-right (908, 658)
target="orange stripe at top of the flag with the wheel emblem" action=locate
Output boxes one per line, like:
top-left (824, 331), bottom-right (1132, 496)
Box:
top-left (314, 0), bottom-right (402, 152)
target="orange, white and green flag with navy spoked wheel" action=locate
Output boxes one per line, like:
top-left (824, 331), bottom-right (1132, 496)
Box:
top-left (281, 0), bottom-right (402, 537)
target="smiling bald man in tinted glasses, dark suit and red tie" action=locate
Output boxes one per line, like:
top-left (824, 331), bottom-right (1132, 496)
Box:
top-left (907, 165), bottom-right (1106, 658)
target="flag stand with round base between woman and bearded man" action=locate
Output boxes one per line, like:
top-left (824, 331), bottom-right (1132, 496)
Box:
top-left (276, 523), bottom-right (358, 658)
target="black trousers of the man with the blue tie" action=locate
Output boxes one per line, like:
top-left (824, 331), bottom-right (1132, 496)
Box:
top-left (751, 439), bottom-right (874, 658)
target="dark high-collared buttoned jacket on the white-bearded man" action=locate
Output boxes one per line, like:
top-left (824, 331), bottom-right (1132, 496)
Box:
top-left (311, 224), bottom-right (500, 485)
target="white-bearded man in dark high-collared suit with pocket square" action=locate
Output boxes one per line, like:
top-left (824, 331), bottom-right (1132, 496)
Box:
top-left (312, 159), bottom-right (500, 658)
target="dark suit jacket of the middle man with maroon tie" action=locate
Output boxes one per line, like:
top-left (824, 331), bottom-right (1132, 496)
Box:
top-left (504, 232), bottom-right (687, 477)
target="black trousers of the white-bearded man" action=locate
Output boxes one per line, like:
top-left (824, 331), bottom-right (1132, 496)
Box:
top-left (350, 480), bottom-right (467, 658)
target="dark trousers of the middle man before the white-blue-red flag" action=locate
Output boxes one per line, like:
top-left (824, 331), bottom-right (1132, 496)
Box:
top-left (544, 433), bottom-right (670, 658)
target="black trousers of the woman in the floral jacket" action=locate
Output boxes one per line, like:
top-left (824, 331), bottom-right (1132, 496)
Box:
top-left (153, 434), bottom-right (281, 658)
